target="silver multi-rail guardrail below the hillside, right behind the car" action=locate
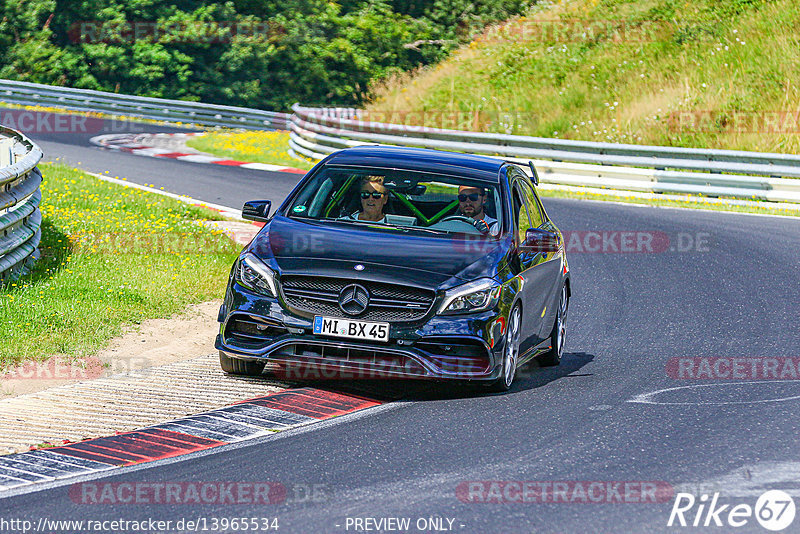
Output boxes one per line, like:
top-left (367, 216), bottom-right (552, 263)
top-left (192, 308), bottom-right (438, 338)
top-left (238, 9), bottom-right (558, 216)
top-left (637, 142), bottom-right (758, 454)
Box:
top-left (289, 105), bottom-right (800, 202)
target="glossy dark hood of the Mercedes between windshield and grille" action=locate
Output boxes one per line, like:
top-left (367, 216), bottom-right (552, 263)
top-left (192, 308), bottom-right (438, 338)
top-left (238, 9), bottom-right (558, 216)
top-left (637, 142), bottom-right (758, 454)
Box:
top-left (248, 215), bottom-right (509, 288)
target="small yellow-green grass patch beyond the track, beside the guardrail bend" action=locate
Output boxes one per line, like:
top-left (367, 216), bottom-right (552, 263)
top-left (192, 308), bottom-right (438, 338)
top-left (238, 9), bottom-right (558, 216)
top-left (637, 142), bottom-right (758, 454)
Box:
top-left (186, 130), bottom-right (315, 170)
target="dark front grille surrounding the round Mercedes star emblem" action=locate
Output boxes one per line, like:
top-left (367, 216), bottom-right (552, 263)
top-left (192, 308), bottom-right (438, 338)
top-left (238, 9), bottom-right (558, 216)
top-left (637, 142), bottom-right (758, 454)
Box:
top-left (281, 275), bottom-right (436, 322)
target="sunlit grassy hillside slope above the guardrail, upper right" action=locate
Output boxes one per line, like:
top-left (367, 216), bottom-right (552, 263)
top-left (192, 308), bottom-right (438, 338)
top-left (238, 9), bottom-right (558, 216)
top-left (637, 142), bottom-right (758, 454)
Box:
top-left (368, 0), bottom-right (800, 152)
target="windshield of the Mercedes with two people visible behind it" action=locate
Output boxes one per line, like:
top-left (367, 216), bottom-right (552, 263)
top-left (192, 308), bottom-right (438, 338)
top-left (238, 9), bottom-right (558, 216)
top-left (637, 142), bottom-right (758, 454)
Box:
top-left (287, 167), bottom-right (502, 237)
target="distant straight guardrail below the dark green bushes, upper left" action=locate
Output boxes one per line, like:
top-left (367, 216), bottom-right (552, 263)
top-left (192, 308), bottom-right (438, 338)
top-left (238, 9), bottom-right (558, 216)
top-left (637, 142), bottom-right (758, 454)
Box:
top-left (0, 80), bottom-right (289, 130)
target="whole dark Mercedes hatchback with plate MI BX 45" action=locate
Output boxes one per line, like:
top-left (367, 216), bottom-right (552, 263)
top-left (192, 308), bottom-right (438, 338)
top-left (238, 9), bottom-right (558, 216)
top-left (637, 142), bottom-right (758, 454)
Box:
top-left (216, 146), bottom-right (570, 390)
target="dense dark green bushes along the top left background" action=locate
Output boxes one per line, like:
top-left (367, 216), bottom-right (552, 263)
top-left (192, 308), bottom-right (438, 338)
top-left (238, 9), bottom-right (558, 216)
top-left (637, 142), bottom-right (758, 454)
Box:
top-left (0, 0), bottom-right (530, 110)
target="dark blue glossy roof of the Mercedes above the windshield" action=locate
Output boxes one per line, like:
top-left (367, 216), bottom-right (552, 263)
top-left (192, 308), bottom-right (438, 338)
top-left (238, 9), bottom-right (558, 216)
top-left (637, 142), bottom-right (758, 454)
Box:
top-left (326, 145), bottom-right (505, 184)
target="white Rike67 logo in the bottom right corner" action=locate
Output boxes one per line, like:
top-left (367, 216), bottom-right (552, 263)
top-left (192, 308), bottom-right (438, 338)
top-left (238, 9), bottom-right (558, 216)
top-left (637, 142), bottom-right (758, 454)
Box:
top-left (667, 490), bottom-right (796, 532)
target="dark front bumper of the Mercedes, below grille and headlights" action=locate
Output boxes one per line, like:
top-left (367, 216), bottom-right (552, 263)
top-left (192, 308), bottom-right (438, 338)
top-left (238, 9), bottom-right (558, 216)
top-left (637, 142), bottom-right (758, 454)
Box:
top-left (215, 283), bottom-right (505, 381)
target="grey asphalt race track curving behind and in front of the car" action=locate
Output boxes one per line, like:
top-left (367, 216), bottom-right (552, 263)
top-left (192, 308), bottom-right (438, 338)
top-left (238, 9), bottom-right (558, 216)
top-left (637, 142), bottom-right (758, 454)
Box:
top-left (0, 114), bottom-right (800, 533)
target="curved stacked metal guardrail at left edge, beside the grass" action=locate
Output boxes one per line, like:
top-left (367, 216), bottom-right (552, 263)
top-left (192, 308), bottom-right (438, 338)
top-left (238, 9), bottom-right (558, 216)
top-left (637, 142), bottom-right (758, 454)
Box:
top-left (0, 126), bottom-right (42, 281)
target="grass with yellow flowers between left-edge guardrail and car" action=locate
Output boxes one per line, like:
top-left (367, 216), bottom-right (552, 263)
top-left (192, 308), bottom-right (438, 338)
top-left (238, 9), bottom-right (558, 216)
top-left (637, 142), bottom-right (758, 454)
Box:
top-left (0, 164), bottom-right (239, 366)
